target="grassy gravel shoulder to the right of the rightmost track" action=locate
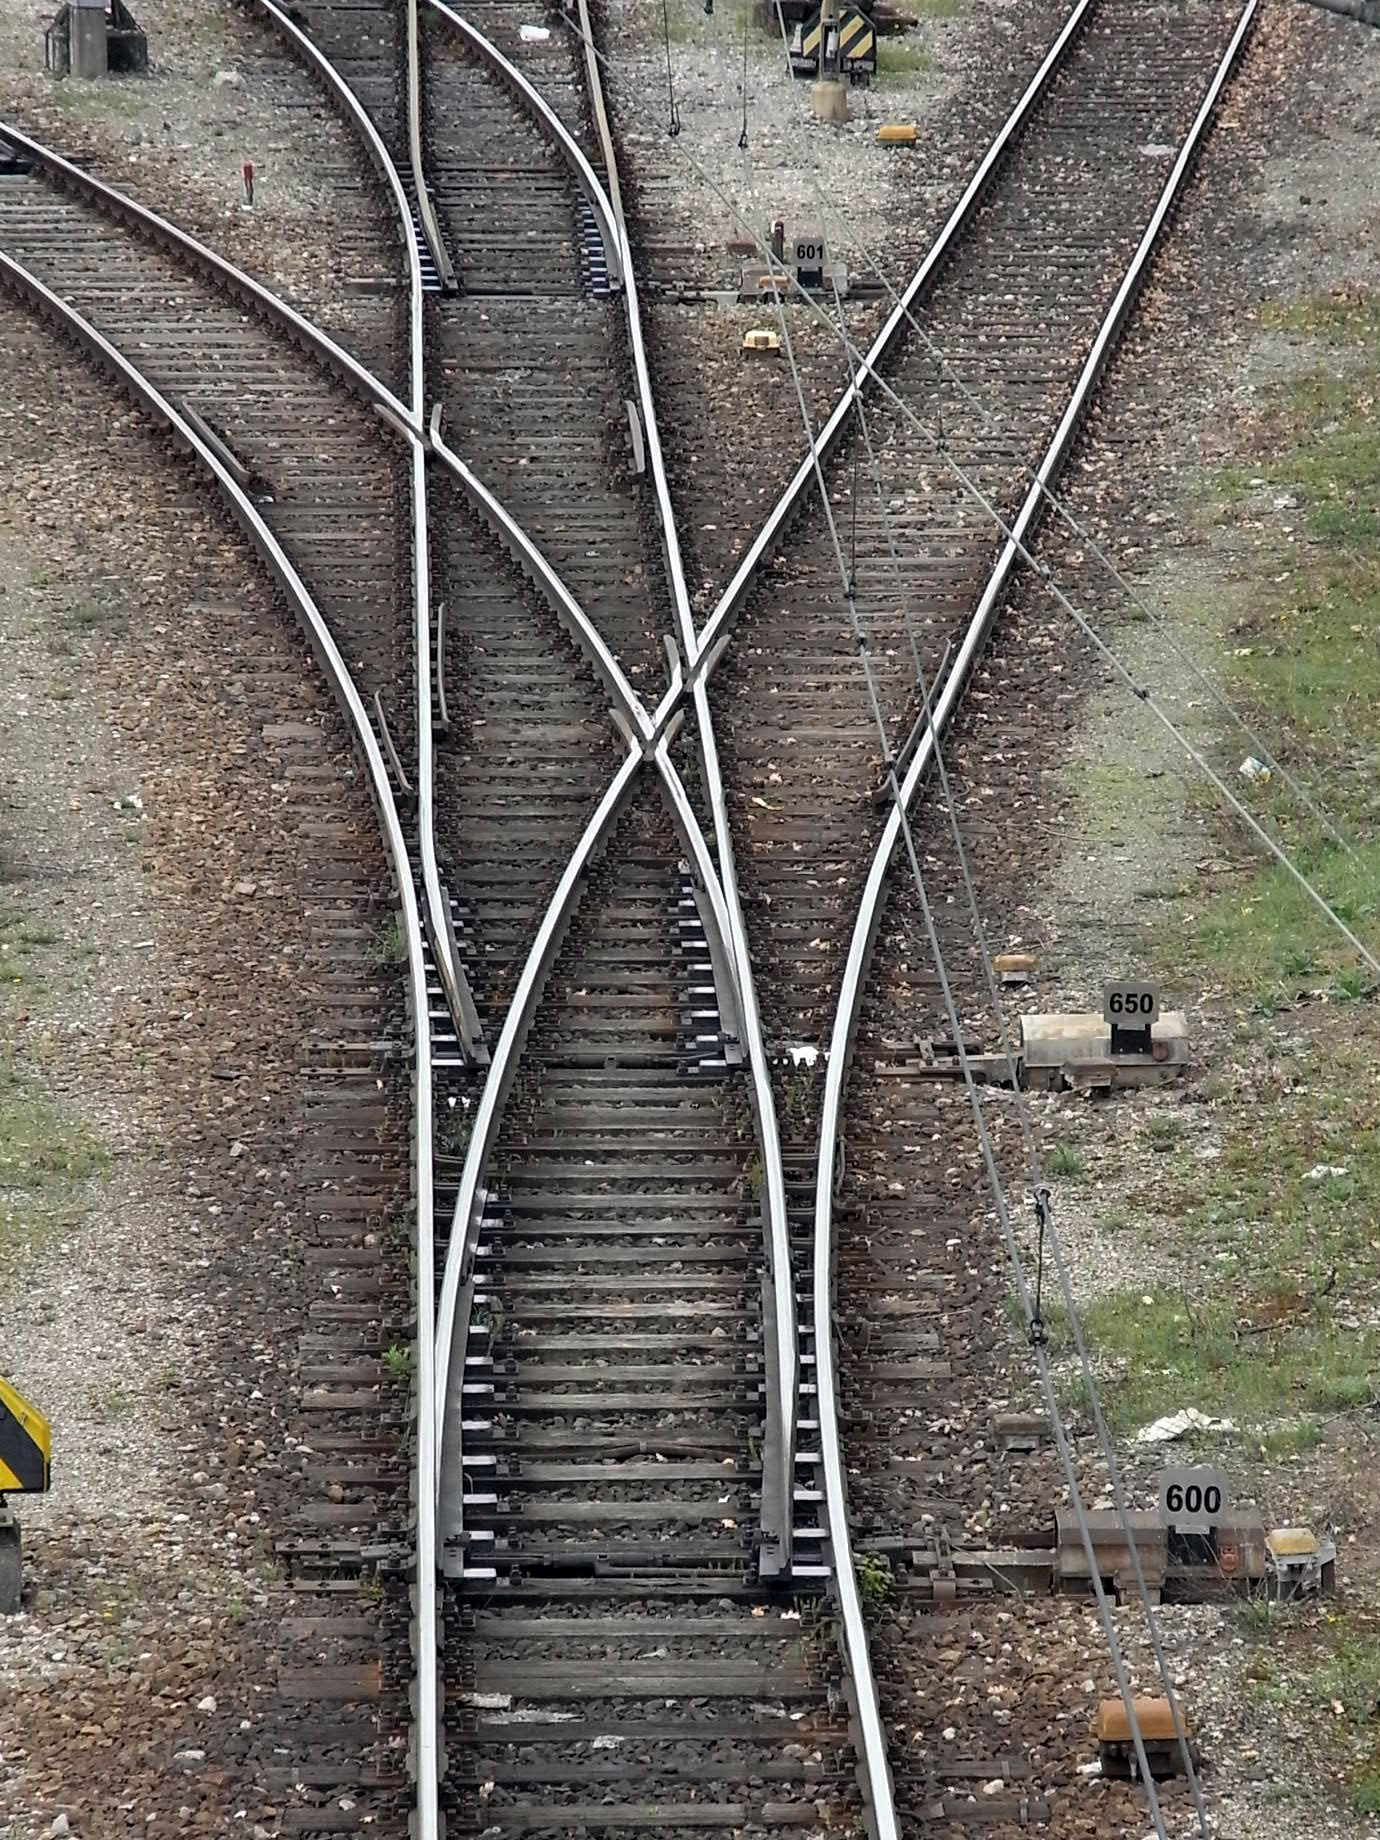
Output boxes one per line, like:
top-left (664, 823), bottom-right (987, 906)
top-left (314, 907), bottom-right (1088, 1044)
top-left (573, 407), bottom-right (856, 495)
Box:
top-left (1010, 7), bottom-right (1380, 1840)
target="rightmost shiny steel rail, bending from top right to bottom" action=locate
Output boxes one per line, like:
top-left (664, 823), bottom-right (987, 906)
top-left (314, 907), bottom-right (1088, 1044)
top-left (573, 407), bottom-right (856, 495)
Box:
top-left (813, 0), bottom-right (1259, 1840)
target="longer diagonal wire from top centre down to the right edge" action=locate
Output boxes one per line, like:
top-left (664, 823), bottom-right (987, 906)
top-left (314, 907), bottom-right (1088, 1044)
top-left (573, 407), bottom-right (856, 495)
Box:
top-left (561, 13), bottom-right (1380, 977)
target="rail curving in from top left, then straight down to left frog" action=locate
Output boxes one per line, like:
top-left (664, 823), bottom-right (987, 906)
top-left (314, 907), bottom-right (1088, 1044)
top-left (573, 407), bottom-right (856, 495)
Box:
top-left (252, 0), bottom-right (478, 1060)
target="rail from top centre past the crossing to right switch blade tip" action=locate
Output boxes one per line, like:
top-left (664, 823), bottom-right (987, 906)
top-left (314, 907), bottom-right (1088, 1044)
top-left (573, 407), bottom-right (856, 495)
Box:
top-left (563, 0), bottom-right (800, 1573)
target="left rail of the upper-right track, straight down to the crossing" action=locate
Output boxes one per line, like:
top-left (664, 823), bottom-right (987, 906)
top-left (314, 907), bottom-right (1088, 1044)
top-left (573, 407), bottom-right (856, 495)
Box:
top-left (688, 0), bottom-right (1097, 683)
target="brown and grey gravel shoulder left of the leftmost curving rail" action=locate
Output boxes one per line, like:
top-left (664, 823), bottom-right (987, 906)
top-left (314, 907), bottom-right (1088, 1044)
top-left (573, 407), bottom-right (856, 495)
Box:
top-left (0, 302), bottom-right (407, 1840)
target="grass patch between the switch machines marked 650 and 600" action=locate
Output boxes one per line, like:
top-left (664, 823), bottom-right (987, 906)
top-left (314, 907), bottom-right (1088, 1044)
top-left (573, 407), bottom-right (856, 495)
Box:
top-left (1051, 1025), bottom-right (1380, 1435)
